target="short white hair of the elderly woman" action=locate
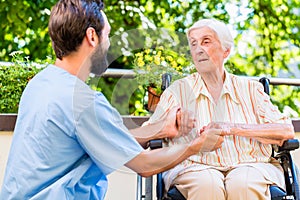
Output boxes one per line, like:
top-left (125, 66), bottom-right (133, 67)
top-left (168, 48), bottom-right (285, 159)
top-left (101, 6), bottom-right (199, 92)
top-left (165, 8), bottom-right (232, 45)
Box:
top-left (187, 19), bottom-right (234, 49)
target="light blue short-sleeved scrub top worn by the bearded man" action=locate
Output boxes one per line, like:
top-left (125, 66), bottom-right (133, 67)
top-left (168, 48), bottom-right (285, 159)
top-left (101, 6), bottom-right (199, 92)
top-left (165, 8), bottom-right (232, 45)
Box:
top-left (0, 65), bottom-right (143, 200)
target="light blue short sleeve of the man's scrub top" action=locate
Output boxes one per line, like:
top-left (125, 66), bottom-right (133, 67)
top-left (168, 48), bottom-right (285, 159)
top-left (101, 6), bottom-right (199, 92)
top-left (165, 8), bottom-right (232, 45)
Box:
top-left (76, 93), bottom-right (143, 174)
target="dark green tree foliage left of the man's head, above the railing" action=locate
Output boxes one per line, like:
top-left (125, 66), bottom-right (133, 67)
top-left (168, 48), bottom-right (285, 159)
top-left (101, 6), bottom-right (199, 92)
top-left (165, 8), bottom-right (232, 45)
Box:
top-left (0, 0), bottom-right (57, 61)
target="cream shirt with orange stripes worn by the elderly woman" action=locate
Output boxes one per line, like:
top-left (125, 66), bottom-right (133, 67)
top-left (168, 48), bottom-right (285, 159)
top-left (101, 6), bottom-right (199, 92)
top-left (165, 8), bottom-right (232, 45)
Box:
top-left (147, 72), bottom-right (291, 191)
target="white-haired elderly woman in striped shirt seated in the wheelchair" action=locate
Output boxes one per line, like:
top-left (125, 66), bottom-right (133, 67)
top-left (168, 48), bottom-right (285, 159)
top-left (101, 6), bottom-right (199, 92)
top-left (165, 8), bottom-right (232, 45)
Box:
top-left (148, 19), bottom-right (294, 200)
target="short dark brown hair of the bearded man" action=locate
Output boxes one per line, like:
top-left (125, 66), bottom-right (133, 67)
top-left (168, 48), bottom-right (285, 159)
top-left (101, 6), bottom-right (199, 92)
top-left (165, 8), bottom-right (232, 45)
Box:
top-left (48, 0), bottom-right (104, 60)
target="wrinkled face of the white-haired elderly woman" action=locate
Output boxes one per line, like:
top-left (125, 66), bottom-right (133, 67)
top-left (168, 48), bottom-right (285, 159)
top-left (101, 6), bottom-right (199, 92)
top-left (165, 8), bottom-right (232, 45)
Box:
top-left (189, 27), bottom-right (229, 74)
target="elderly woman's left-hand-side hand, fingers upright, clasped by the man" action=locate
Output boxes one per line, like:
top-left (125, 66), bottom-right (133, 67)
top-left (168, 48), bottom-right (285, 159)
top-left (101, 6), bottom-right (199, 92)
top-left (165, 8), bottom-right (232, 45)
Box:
top-left (176, 109), bottom-right (196, 137)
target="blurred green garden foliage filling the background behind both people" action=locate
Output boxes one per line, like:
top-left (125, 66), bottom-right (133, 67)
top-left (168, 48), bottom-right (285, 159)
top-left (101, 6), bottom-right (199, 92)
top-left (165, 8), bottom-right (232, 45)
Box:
top-left (0, 0), bottom-right (300, 118)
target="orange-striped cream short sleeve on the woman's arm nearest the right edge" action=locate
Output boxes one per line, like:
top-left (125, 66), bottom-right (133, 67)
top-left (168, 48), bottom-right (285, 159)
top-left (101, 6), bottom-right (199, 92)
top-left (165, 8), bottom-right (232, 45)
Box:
top-left (252, 82), bottom-right (291, 124)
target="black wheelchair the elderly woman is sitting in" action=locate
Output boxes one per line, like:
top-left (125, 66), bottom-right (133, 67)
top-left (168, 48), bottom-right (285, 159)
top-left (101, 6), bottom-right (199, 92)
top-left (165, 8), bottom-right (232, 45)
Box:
top-left (136, 74), bottom-right (300, 200)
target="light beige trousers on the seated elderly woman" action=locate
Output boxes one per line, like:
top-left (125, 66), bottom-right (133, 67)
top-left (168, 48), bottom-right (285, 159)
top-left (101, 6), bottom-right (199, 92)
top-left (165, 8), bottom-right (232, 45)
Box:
top-left (173, 166), bottom-right (271, 200)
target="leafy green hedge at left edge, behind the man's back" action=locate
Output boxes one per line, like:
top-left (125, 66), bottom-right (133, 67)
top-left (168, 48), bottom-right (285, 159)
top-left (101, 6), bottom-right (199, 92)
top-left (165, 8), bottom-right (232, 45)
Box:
top-left (0, 52), bottom-right (42, 113)
